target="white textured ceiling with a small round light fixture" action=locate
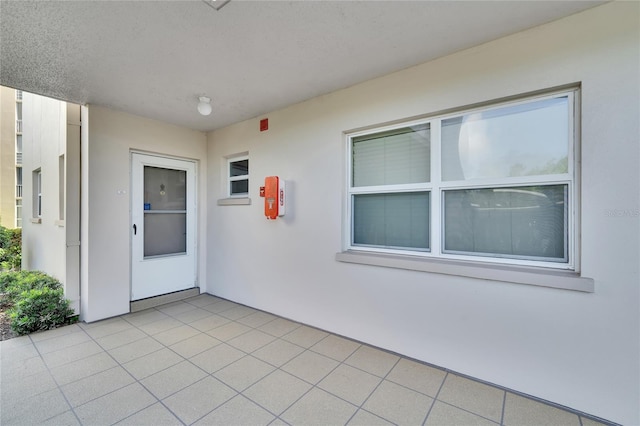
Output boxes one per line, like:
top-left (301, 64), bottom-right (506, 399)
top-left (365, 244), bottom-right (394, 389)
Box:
top-left (0, 0), bottom-right (603, 131)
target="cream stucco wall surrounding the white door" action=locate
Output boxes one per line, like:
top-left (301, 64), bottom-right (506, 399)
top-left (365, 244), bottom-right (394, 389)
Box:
top-left (81, 105), bottom-right (207, 322)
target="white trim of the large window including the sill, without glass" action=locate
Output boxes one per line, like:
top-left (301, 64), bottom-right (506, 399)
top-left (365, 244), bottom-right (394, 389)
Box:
top-left (336, 86), bottom-right (594, 292)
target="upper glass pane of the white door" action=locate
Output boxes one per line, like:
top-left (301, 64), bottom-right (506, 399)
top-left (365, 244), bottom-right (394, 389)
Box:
top-left (144, 166), bottom-right (187, 210)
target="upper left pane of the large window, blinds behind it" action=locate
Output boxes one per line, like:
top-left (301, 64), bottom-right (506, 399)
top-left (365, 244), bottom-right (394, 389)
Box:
top-left (352, 124), bottom-right (431, 187)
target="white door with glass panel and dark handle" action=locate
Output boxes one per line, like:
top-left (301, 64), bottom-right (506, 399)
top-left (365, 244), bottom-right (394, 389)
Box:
top-left (131, 153), bottom-right (196, 300)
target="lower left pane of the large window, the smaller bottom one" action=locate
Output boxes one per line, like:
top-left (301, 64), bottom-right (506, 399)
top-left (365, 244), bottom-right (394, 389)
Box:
top-left (353, 192), bottom-right (429, 251)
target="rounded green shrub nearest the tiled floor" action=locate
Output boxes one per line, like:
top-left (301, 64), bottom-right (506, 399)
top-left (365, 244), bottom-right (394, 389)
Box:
top-left (9, 287), bottom-right (76, 335)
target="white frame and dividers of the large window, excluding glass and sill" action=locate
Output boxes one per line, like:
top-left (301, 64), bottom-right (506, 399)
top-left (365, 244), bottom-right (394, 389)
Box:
top-left (343, 86), bottom-right (580, 272)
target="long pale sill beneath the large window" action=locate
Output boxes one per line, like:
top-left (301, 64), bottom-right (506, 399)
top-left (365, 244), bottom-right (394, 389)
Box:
top-left (336, 251), bottom-right (595, 293)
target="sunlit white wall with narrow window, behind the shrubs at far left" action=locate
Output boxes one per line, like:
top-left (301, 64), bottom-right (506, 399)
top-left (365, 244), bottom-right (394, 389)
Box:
top-left (22, 92), bottom-right (70, 300)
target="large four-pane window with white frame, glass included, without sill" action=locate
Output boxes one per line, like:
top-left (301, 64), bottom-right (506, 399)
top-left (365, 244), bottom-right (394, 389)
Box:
top-left (347, 90), bottom-right (577, 269)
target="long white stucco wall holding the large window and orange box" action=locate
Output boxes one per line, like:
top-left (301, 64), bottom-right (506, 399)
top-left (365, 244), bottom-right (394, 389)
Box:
top-left (207, 2), bottom-right (640, 424)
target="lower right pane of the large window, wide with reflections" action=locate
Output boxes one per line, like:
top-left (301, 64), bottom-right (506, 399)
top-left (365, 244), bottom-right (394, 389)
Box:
top-left (444, 185), bottom-right (568, 262)
